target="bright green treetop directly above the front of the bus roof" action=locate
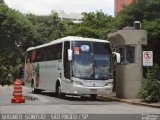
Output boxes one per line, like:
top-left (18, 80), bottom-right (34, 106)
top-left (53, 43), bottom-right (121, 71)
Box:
top-left (67, 11), bottom-right (114, 39)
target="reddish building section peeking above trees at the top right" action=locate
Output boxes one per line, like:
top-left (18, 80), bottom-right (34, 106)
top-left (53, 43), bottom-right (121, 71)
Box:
top-left (114, 0), bottom-right (136, 15)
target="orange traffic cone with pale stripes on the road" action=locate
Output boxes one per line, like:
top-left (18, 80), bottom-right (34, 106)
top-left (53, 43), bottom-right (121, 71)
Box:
top-left (11, 79), bottom-right (25, 103)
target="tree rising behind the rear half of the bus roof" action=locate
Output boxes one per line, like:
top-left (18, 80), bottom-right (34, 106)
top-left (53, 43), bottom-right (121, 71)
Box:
top-left (26, 13), bottom-right (66, 44)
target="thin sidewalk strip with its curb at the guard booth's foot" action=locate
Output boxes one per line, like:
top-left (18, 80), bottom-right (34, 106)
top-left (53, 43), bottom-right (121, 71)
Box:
top-left (99, 92), bottom-right (160, 108)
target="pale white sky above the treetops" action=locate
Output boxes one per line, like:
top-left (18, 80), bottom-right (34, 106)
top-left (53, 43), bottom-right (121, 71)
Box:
top-left (4, 0), bottom-right (114, 16)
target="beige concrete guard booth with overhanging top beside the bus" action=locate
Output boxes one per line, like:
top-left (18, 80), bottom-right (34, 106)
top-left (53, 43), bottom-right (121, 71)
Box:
top-left (108, 24), bottom-right (147, 99)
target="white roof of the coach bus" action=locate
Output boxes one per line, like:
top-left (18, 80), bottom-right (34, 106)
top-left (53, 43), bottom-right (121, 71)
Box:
top-left (27, 36), bottom-right (110, 51)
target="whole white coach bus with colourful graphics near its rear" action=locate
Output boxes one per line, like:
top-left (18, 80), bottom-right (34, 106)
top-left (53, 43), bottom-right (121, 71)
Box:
top-left (25, 36), bottom-right (120, 99)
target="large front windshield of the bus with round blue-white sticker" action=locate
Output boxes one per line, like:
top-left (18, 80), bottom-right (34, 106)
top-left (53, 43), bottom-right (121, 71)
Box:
top-left (72, 41), bottom-right (112, 80)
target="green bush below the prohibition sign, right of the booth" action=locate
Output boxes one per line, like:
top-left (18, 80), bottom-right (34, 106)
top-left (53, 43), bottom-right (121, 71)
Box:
top-left (140, 65), bottom-right (160, 102)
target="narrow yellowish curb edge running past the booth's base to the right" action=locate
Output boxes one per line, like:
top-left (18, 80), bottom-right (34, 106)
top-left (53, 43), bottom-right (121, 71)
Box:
top-left (98, 96), bottom-right (160, 108)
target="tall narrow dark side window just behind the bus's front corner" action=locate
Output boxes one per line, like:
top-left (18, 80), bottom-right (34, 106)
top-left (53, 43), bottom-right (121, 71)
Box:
top-left (63, 41), bottom-right (70, 79)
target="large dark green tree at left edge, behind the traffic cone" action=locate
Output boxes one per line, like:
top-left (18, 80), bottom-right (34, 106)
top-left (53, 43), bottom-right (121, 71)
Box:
top-left (0, 4), bottom-right (37, 79)
